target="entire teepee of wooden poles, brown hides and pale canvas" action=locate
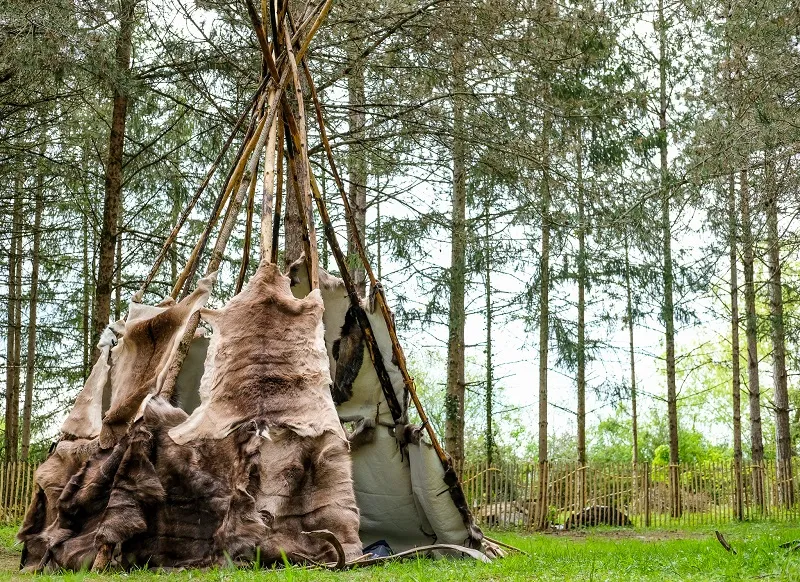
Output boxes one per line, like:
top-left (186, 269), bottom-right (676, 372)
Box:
top-left (19, 0), bottom-right (501, 571)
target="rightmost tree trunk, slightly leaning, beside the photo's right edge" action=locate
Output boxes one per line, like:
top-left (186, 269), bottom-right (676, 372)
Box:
top-left (764, 152), bottom-right (794, 507)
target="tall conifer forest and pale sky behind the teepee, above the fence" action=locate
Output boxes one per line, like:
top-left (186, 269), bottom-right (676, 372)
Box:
top-left (0, 0), bottom-right (800, 488)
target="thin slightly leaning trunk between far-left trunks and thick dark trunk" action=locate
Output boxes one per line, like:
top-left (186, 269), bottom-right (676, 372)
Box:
top-left (20, 170), bottom-right (44, 461)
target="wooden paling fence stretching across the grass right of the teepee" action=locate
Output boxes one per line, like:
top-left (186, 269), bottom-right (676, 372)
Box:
top-left (461, 461), bottom-right (800, 528)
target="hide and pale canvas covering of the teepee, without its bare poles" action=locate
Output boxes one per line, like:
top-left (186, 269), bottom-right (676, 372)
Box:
top-left (19, 261), bottom-right (497, 570)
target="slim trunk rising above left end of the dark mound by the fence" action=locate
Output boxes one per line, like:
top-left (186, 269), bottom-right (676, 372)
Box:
top-left (576, 135), bottom-right (586, 467)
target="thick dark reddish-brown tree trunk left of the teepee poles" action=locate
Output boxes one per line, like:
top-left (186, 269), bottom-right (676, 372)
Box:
top-left (92, 0), bottom-right (137, 362)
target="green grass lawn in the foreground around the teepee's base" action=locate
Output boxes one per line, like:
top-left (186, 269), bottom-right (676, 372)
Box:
top-left (0, 523), bottom-right (800, 582)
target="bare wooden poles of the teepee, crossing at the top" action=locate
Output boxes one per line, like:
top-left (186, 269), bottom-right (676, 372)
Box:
top-left (134, 0), bottom-right (472, 544)
